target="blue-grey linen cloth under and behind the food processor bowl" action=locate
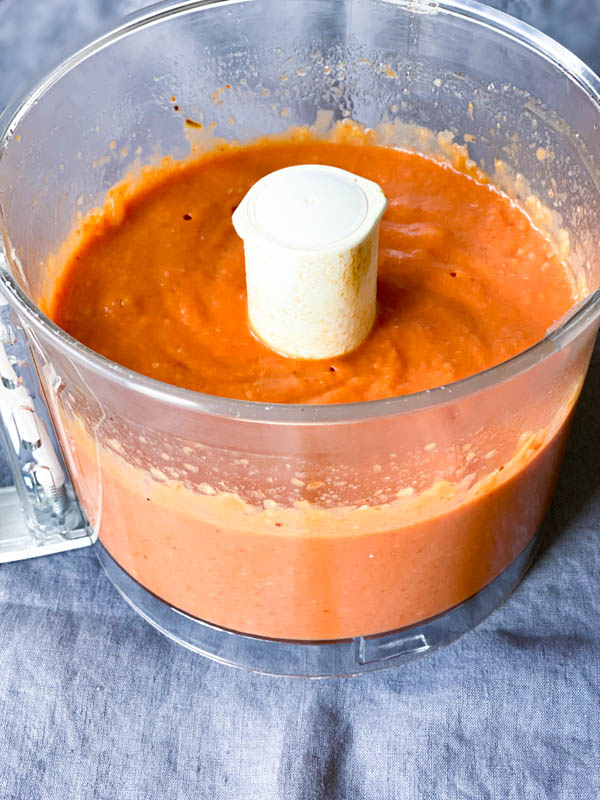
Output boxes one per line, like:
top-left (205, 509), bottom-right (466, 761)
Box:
top-left (0, 0), bottom-right (600, 800)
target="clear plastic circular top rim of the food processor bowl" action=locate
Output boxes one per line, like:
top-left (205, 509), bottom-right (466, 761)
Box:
top-left (0, 0), bottom-right (600, 425)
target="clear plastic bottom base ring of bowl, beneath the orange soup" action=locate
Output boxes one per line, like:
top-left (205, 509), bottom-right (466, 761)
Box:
top-left (94, 530), bottom-right (541, 678)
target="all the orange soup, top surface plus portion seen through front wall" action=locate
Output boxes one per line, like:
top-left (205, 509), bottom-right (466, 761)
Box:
top-left (47, 132), bottom-right (577, 640)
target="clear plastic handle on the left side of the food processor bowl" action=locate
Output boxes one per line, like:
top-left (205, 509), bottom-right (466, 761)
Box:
top-left (0, 288), bottom-right (93, 563)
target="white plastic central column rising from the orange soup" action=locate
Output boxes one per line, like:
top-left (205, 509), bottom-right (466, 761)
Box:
top-left (233, 164), bottom-right (387, 359)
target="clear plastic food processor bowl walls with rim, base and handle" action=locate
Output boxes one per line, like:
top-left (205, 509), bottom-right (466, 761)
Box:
top-left (0, 0), bottom-right (600, 677)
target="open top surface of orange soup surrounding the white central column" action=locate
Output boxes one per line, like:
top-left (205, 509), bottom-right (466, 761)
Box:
top-left (51, 140), bottom-right (573, 403)
